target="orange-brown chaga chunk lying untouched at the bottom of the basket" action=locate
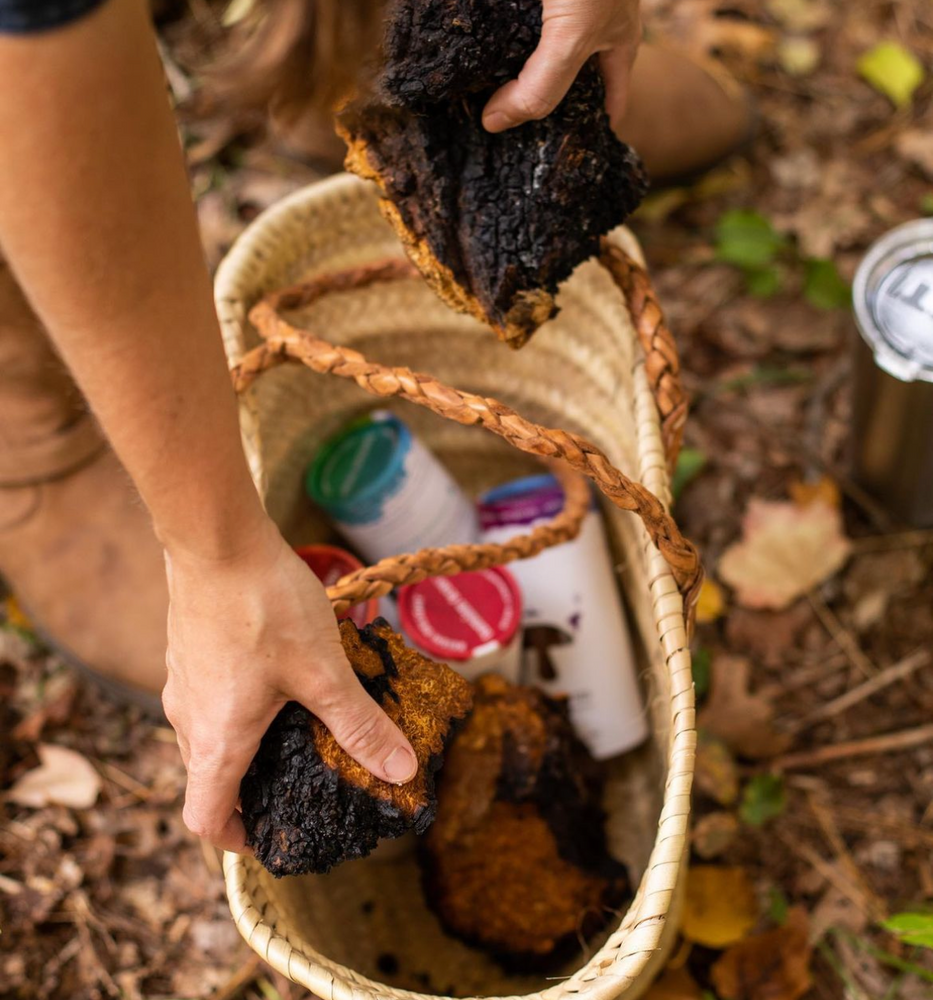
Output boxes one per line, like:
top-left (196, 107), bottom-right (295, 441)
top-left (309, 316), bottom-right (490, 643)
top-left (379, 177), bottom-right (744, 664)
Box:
top-left (423, 674), bottom-right (629, 967)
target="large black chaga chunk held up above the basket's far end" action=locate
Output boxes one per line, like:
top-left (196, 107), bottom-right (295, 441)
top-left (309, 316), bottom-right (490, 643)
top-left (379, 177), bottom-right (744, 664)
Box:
top-left (338, 0), bottom-right (646, 347)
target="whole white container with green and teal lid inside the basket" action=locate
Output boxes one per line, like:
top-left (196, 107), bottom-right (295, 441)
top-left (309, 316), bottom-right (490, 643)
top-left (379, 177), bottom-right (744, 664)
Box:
top-left (305, 410), bottom-right (479, 562)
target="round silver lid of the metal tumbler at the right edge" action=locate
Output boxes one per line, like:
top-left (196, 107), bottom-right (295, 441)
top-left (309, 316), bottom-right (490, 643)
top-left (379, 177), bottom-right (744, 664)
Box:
top-left (852, 219), bottom-right (933, 382)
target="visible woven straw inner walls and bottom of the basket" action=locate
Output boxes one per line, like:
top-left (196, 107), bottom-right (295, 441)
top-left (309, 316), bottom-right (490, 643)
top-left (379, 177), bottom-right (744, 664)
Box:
top-left (225, 176), bottom-right (670, 996)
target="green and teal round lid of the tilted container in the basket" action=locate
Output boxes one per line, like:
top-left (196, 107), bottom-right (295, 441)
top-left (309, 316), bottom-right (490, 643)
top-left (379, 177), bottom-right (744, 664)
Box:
top-left (305, 410), bottom-right (411, 523)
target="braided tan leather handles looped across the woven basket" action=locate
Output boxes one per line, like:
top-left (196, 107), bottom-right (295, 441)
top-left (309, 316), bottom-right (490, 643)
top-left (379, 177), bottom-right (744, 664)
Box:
top-left (231, 254), bottom-right (702, 619)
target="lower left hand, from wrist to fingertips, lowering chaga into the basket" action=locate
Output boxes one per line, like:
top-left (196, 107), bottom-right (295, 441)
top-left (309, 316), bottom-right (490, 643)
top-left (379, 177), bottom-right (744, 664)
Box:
top-left (162, 521), bottom-right (417, 851)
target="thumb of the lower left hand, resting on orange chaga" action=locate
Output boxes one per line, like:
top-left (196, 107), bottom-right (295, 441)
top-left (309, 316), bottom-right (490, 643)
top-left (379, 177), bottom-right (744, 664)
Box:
top-left (296, 658), bottom-right (418, 785)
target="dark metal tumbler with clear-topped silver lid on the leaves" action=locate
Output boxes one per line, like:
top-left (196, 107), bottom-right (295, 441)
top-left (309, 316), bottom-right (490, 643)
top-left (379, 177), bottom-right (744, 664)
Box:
top-left (852, 219), bottom-right (933, 527)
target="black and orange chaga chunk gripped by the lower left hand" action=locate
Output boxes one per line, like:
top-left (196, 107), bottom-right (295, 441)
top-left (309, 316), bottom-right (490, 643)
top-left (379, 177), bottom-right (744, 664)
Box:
top-left (240, 619), bottom-right (471, 877)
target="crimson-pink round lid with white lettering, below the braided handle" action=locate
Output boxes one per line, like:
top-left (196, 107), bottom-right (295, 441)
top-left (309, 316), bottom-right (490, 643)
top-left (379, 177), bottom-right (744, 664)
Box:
top-left (398, 567), bottom-right (522, 660)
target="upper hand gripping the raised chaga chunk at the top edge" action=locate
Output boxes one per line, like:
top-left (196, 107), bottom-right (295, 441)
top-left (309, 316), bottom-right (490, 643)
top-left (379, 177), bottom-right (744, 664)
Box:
top-left (483, 0), bottom-right (641, 132)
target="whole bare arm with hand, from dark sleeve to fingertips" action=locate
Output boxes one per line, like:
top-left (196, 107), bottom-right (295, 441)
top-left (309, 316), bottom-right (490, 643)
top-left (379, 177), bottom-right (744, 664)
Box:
top-left (0, 0), bottom-right (415, 850)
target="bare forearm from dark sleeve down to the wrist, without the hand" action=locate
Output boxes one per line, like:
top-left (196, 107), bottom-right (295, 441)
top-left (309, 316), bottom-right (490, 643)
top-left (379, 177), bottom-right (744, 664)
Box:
top-left (0, 0), bottom-right (262, 558)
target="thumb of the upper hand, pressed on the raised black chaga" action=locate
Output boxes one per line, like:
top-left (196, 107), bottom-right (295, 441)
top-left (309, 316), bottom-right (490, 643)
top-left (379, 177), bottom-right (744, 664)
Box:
top-left (483, 18), bottom-right (592, 132)
